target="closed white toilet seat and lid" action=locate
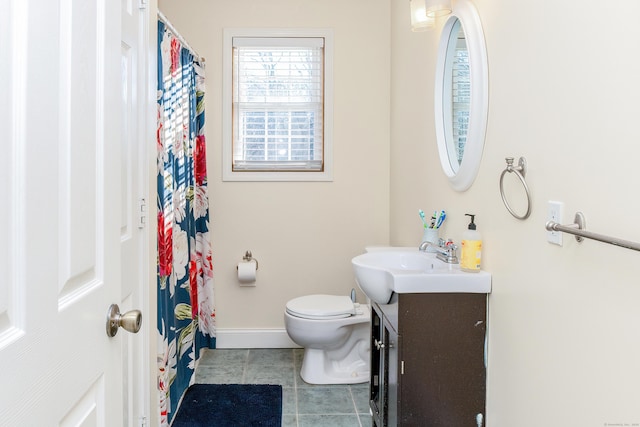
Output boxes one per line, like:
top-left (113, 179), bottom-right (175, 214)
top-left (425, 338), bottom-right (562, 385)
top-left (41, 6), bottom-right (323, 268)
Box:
top-left (286, 295), bottom-right (359, 320)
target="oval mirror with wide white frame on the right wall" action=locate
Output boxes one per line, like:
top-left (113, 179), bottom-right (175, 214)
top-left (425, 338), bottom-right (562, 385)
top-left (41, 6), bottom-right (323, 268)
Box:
top-left (435, 0), bottom-right (489, 191)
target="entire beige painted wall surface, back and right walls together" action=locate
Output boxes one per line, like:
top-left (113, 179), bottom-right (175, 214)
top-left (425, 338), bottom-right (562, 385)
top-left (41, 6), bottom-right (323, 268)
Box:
top-left (159, 0), bottom-right (640, 427)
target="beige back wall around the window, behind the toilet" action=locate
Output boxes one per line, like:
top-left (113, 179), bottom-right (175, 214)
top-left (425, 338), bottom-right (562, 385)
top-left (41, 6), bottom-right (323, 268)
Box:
top-left (158, 0), bottom-right (390, 330)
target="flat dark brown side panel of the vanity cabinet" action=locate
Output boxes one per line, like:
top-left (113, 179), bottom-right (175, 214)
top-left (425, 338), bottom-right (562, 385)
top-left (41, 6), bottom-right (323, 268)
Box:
top-left (398, 293), bottom-right (487, 427)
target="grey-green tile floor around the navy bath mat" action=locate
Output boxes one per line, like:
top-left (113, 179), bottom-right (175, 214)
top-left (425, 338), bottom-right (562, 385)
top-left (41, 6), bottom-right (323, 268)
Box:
top-left (196, 349), bottom-right (371, 427)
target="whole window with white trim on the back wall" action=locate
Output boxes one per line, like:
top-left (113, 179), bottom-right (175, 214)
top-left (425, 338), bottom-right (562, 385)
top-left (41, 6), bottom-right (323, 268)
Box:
top-left (223, 30), bottom-right (332, 181)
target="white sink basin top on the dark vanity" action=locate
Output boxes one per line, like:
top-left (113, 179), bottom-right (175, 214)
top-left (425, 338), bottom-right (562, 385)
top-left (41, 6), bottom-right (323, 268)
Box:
top-left (351, 247), bottom-right (491, 304)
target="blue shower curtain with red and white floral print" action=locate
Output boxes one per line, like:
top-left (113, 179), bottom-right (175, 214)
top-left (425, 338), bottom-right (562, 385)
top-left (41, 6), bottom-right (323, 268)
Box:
top-left (157, 21), bottom-right (216, 426)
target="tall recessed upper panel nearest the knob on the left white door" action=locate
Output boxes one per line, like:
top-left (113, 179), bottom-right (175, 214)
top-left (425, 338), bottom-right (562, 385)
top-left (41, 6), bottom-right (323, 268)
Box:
top-left (57, 1), bottom-right (100, 309)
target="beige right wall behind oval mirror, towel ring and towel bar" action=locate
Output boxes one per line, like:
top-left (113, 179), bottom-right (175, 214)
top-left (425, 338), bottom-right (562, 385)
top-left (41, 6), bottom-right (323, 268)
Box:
top-left (390, 0), bottom-right (640, 427)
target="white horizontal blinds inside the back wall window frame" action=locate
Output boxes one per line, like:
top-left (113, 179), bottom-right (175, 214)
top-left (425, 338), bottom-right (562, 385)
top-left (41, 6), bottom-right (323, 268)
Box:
top-left (232, 37), bottom-right (324, 172)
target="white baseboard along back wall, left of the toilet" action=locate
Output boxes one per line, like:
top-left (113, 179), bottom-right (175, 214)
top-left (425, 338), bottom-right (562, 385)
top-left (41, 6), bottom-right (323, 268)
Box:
top-left (216, 328), bottom-right (300, 348)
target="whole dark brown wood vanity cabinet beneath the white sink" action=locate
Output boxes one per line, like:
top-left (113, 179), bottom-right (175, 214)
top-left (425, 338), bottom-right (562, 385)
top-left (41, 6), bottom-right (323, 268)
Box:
top-left (370, 293), bottom-right (487, 427)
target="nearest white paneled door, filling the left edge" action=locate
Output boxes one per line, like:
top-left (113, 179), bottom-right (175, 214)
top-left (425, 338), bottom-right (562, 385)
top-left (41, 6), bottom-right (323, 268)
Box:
top-left (0, 0), bottom-right (141, 427)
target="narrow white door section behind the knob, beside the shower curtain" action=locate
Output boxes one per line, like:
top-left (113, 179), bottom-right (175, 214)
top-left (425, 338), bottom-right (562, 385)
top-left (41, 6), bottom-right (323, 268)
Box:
top-left (119, 0), bottom-right (152, 427)
